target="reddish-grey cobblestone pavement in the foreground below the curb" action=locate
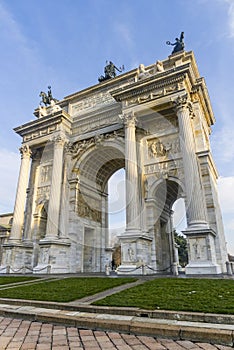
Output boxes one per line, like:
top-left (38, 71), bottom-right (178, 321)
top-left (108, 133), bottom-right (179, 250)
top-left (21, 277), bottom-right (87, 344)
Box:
top-left (0, 317), bottom-right (232, 350)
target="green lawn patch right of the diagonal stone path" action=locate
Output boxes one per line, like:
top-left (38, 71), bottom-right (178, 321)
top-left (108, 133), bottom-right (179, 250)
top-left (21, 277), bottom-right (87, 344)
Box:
top-left (93, 278), bottom-right (234, 314)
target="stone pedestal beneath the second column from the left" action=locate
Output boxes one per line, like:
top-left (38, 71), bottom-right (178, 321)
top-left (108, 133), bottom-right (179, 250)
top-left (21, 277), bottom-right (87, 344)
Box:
top-left (33, 239), bottom-right (71, 274)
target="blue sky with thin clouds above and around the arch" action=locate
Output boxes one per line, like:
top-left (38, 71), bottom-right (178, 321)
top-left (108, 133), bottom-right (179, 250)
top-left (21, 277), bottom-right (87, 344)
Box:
top-left (0, 0), bottom-right (234, 254)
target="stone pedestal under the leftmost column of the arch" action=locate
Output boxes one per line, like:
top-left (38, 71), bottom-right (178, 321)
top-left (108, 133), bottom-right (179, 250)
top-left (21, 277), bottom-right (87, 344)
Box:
top-left (0, 242), bottom-right (33, 273)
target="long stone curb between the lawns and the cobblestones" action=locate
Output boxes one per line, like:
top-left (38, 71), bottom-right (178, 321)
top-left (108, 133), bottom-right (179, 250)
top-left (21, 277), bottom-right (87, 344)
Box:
top-left (0, 299), bottom-right (234, 346)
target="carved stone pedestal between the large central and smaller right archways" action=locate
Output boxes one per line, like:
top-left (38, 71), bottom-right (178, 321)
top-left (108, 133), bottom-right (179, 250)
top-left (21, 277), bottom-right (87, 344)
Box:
top-left (117, 234), bottom-right (153, 275)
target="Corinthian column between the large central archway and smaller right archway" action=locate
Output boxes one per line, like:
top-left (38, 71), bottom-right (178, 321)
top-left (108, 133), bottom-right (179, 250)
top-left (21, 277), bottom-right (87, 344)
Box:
top-left (122, 112), bottom-right (140, 232)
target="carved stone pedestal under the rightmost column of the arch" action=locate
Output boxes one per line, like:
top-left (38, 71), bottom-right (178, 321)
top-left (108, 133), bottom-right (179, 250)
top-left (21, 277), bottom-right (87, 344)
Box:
top-left (183, 229), bottom-right (222, 275)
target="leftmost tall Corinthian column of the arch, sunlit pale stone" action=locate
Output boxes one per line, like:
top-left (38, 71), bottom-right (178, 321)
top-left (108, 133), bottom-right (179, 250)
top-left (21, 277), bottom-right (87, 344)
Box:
top-left (10, 145), bottom-right (31, 241)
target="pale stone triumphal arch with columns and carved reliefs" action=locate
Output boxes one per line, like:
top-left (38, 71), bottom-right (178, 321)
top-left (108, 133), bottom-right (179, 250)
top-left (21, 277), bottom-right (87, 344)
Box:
top-left (1, 50), bottom-right (228, 274)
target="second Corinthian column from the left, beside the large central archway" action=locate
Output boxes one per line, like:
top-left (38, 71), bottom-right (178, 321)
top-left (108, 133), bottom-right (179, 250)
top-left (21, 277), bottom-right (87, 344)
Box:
top-left (45, 136), bottom-right (65, 239)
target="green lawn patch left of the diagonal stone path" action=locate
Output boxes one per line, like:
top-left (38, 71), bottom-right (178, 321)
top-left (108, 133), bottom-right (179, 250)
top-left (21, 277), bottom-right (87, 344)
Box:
top-left (0, 277), bottom-right (137, 302)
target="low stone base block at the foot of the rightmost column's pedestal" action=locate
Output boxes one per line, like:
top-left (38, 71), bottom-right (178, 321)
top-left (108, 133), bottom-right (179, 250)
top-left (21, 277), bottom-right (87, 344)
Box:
top-left (185, 262), bottom-right (222, 275)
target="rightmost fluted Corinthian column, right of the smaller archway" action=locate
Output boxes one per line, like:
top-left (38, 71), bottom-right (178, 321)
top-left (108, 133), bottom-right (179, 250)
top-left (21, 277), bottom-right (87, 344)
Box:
top-left (174, 96), bottom-right (208, 229)
